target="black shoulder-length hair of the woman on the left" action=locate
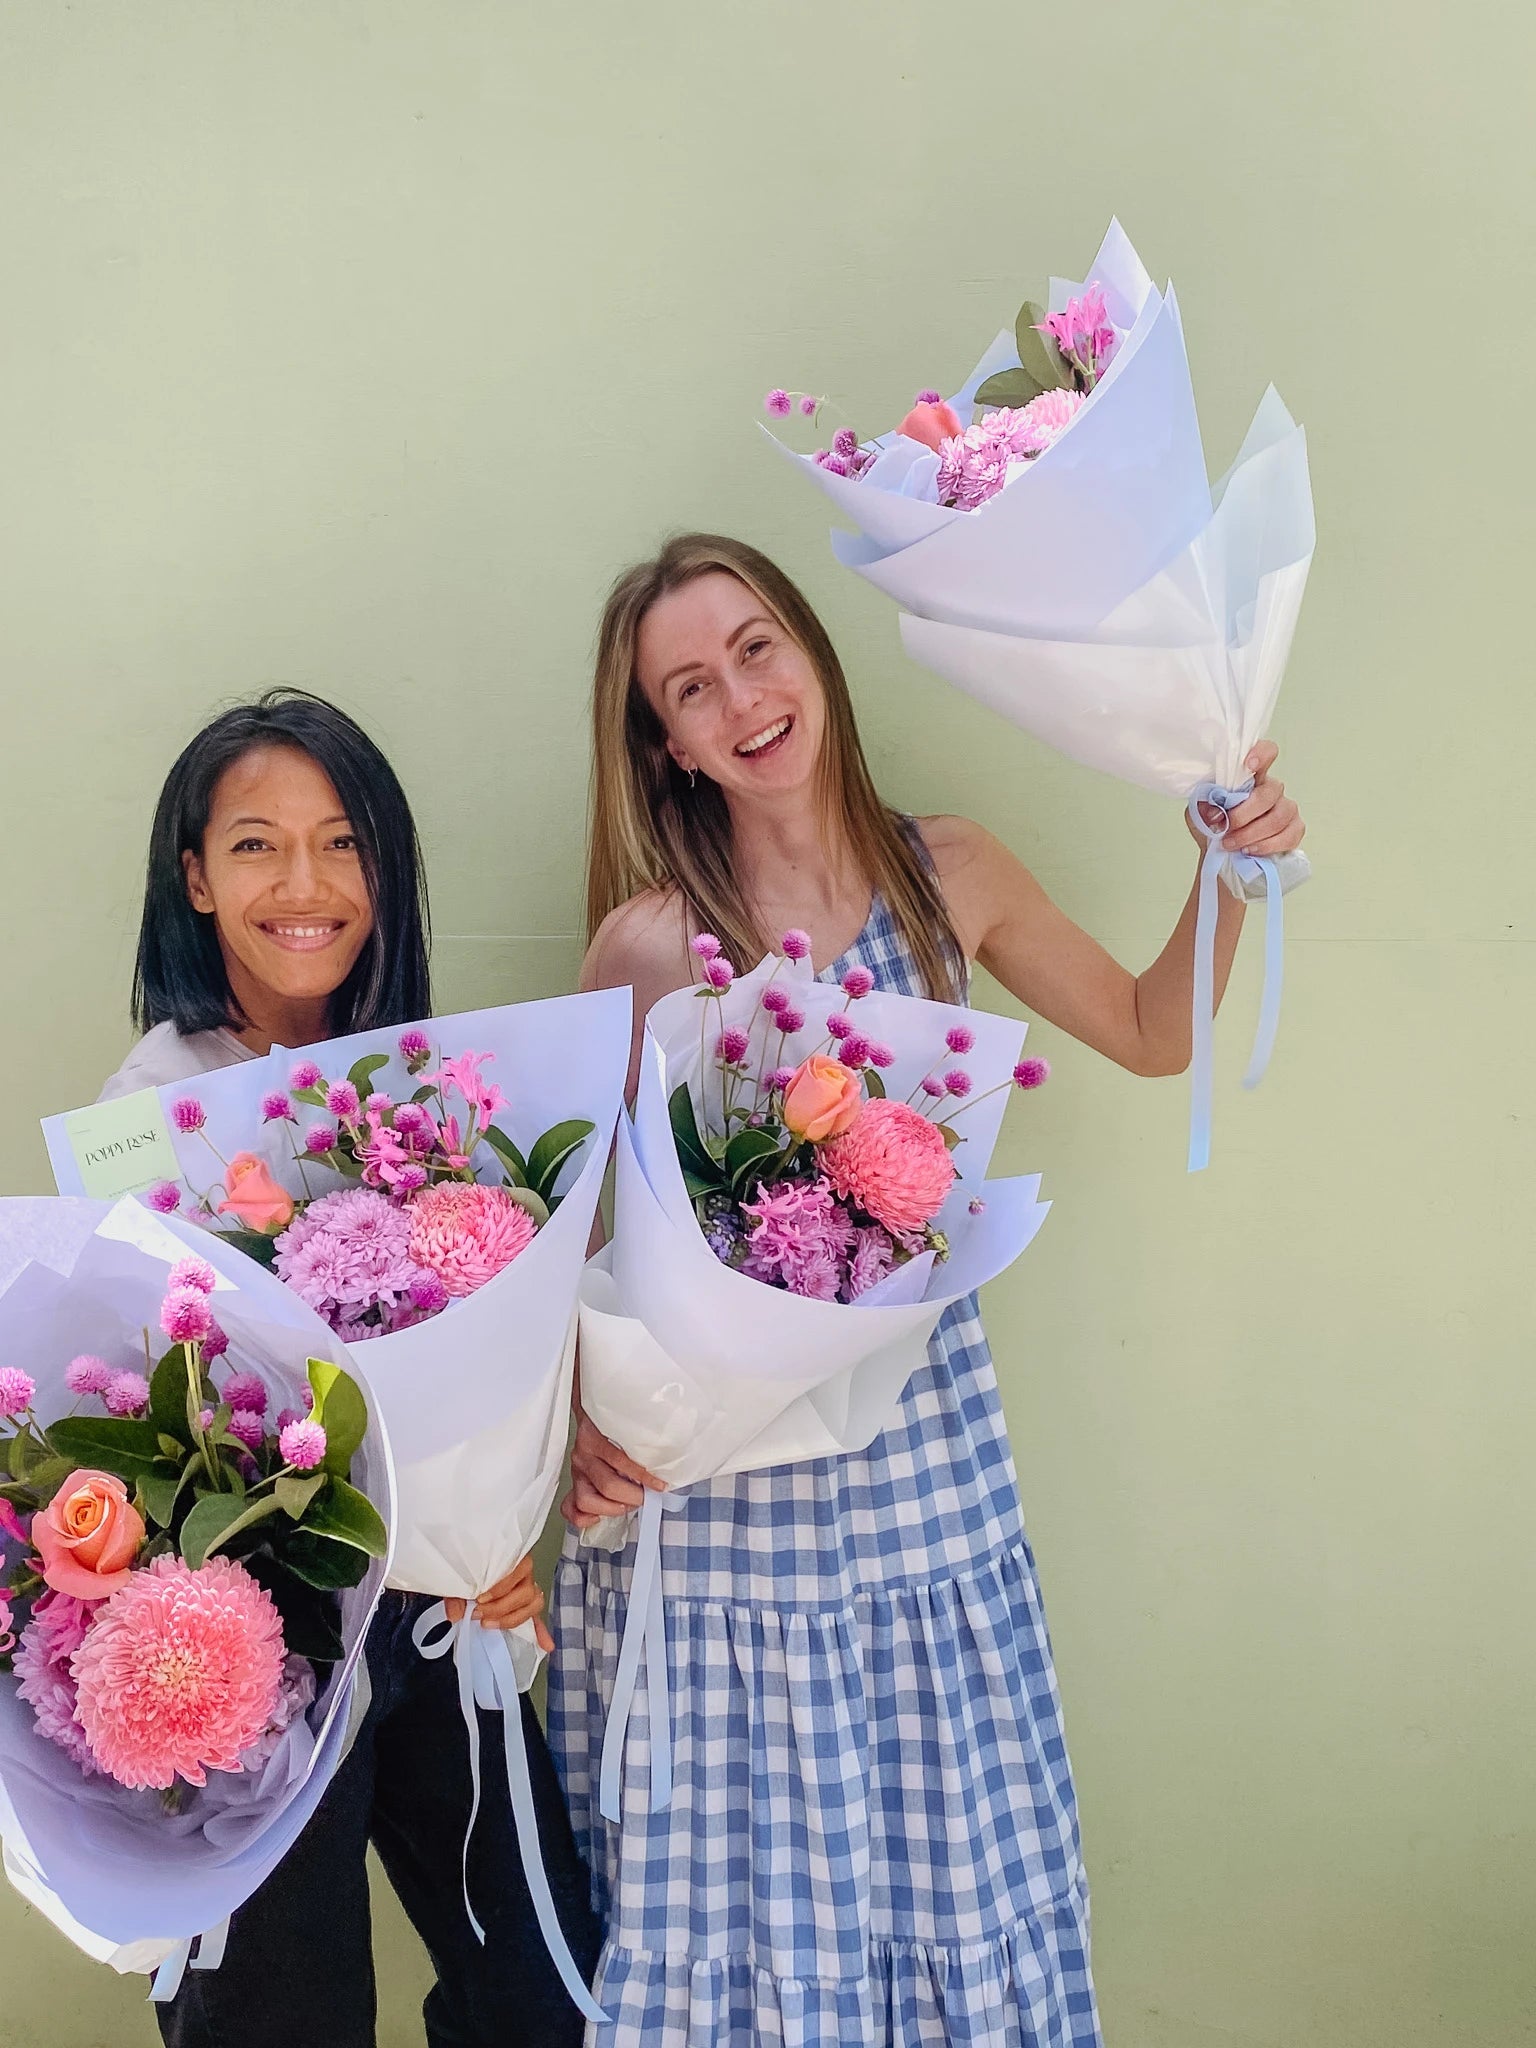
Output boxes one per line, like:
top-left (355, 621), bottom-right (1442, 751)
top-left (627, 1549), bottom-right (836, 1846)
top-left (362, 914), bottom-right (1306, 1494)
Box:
top-left (133, 688), bottom-right (432, 1038)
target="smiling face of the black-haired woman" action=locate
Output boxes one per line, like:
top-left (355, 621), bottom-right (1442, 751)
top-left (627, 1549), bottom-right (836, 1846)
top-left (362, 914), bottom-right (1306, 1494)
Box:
top-left (182, 745), bottom-right (373, 1036)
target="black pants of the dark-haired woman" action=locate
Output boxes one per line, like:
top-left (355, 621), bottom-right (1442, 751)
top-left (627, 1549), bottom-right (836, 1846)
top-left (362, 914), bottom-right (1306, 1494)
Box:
top-left (156, 1593), bottom-right (598, 2048)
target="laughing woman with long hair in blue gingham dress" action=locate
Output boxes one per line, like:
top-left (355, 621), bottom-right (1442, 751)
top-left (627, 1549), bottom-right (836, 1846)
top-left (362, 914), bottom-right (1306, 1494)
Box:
top-left (549, 535), bottom-right (1303, 2048)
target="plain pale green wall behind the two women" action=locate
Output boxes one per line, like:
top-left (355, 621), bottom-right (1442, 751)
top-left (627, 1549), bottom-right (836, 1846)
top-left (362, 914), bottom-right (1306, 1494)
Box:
top-left (0, 0), bottom-right (1536, 2048)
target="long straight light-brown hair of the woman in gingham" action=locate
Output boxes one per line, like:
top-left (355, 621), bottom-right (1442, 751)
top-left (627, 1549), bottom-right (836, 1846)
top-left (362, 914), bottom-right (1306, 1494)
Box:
top-left (586, 532), bottom-right (965, 1001)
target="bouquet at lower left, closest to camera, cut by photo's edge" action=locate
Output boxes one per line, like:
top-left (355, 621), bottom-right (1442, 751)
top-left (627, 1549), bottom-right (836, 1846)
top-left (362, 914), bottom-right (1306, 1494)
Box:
top-left (0, 1202), bottom-right (393, 1997)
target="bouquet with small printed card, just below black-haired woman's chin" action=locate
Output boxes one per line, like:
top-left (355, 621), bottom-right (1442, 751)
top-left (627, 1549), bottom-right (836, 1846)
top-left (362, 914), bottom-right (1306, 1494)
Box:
top-left (43, 989), bottom-right (631, 2017)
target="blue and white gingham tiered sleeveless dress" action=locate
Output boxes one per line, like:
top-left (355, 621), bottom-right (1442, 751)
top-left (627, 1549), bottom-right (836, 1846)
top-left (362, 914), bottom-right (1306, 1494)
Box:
top-left (549, 899), bottom-right (1100, 2048)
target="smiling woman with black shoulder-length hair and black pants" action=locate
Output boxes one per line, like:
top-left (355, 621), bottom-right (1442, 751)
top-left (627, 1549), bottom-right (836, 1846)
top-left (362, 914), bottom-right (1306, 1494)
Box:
top-left (104, 690), bottom-right (598, 2048)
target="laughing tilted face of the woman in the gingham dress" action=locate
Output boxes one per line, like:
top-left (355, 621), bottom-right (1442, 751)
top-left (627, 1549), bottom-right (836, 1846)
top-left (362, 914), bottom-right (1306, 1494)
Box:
top-left (635, 569), bottom-right (827, 799)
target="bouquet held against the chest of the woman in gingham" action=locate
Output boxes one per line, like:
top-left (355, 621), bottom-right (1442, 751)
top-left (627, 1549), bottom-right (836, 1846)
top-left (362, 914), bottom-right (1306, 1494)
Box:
top-left (582, 932), bottom-right (1049, 1817)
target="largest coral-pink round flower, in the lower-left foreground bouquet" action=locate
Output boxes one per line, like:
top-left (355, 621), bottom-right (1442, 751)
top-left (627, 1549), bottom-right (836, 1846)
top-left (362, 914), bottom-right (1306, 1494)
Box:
top-left (70, 1556), bottom-right (285, 1790)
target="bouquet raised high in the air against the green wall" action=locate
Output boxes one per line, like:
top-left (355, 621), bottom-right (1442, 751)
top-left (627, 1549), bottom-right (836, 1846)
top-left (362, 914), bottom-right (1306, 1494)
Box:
top-left (768, 223), bottom-right (1315, 1167)
